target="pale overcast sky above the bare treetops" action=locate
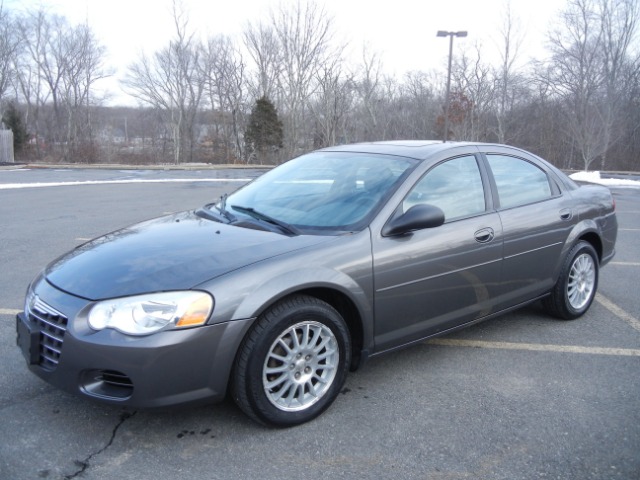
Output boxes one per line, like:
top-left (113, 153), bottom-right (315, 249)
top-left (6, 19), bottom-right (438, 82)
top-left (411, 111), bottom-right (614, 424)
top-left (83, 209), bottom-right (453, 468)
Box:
top-left (4, 0), bottom-right (566, 105)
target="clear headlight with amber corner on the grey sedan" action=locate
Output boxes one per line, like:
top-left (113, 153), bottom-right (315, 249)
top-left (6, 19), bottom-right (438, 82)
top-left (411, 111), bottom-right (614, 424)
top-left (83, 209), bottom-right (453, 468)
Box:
top-left (89, 291), bottom-right (213, 335)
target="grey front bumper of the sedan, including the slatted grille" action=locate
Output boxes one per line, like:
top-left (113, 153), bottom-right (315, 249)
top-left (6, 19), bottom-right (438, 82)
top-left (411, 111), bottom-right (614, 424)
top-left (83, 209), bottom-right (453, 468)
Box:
top-left (16, 280), bottom-right (253, 408)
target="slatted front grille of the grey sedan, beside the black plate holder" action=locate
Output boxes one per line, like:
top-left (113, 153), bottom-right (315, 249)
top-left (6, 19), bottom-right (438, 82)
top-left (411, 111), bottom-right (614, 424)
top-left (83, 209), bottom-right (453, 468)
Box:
top-left (29, 297), bottom-right (68, 370)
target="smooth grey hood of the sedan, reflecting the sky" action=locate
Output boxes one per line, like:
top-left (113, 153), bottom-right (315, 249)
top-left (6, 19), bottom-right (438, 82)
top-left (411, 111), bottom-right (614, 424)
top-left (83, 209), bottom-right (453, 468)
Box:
top-left (45, 212), bottom-right (331, 300)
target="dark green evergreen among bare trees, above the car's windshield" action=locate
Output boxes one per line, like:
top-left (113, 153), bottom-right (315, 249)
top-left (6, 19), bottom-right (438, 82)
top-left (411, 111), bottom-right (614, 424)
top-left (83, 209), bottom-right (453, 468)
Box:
top-left (245, 97), bottom-right (283, 160)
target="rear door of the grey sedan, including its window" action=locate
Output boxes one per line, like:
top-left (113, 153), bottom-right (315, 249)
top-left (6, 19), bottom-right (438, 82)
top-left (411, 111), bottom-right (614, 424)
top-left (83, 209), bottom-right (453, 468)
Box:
top-left (486, 153), bottom-right (576, 308)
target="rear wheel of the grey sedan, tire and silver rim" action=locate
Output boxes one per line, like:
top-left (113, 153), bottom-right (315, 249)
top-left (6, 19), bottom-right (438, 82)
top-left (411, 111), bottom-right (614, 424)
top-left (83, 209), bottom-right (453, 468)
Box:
top-left (543, 241), bottom-right (599, 320)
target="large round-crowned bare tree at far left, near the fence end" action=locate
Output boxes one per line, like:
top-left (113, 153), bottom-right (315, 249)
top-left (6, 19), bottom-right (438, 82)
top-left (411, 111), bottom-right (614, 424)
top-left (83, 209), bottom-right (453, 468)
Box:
top-left (12, 9), bottom-right (105, 161)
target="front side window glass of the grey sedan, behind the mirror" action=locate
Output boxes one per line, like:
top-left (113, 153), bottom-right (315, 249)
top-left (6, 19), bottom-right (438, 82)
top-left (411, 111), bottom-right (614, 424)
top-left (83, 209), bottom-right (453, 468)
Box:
top-left (402, 155), bottom-right (486, 222)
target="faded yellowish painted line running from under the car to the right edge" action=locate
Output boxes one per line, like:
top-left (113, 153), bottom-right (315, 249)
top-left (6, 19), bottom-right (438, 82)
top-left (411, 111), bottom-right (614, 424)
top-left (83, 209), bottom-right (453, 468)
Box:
top-left (424, 338), bottom-right (640, 357)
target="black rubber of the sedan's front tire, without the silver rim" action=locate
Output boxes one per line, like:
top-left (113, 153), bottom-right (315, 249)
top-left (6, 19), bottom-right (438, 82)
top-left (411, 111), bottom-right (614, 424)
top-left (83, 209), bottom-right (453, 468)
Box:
top-left (245, 297), bottom-right (351, 427)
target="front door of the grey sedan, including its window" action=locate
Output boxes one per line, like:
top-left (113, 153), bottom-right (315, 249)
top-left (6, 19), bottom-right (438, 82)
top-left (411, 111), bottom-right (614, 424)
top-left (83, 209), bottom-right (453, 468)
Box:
top-left (372, 155), bottom-right (502, 351)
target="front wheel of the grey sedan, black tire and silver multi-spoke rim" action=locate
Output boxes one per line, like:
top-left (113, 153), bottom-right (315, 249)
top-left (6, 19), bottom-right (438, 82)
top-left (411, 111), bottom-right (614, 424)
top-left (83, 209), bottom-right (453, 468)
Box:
top-left (231, 295), bottom-right (351, 427)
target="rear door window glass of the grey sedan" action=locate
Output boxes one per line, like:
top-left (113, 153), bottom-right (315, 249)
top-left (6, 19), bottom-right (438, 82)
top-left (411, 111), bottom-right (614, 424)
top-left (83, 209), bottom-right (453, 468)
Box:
top-left (487, 155), bottom-right (552, 208)
